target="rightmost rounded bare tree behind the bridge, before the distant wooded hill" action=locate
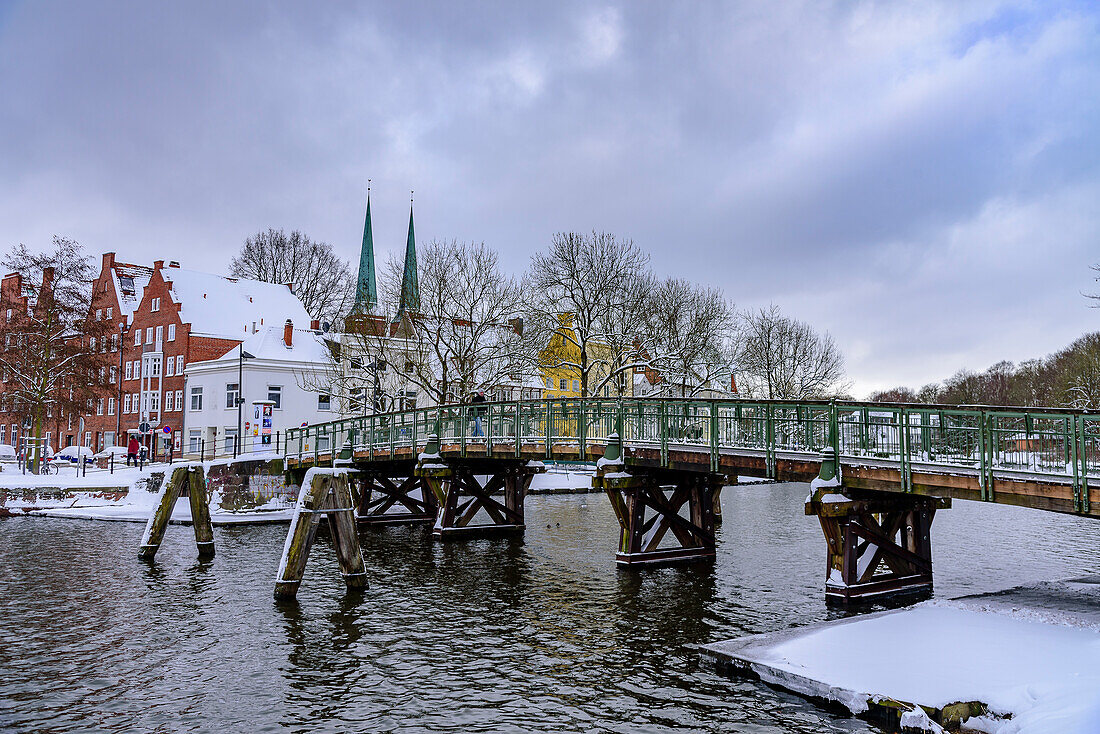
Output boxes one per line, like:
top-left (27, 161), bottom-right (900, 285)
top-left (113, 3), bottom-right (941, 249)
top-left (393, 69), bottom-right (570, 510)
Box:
top-left (739, 305), bottom-right (844, 399)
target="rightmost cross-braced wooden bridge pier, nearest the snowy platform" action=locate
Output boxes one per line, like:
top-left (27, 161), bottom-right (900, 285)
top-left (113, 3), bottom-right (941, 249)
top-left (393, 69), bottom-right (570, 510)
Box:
top-left (806, 487), bottom-right (952, 605)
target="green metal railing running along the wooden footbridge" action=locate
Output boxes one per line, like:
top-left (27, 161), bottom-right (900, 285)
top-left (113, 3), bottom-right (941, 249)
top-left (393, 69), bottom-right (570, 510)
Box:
top-left (286, 398), bottom-right (1100, 511)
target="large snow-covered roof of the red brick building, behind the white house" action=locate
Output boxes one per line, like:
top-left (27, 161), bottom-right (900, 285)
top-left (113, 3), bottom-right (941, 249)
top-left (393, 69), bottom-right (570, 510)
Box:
top-left (161, 267), bottom-right (310, 341)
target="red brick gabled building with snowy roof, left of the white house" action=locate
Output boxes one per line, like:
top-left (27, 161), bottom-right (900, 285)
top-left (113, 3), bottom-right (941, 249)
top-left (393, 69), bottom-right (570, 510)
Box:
top-left (0, 252), bottom-right (309, 454)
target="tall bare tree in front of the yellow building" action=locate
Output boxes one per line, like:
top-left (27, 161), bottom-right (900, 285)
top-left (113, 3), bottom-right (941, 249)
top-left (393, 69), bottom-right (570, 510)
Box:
top-left (527, 232), bottom-right (652, 396)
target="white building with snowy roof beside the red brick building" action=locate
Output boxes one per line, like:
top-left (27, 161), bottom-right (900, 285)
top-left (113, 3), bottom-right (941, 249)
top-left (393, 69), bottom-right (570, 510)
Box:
top-left (183, 321), bottom-right (338, 457)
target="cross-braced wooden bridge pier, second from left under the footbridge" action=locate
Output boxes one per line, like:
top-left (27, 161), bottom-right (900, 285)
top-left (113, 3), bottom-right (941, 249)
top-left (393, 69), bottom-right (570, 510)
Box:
top-left (416, 460), bottom-right (546, 538)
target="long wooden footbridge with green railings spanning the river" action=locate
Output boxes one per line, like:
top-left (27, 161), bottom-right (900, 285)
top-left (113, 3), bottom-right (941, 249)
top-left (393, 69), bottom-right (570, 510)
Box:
top-left (141, 398), bottom-right (1100, 603)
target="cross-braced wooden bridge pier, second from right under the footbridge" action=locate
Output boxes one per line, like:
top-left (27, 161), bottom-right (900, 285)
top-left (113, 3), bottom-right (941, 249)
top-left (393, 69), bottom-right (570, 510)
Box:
top-left (593, 464), bottom-right (725, 567)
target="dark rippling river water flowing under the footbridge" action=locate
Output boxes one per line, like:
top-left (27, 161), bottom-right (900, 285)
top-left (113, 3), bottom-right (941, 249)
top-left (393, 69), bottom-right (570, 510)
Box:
top-left (0, 484), bottom-right (1100, 734)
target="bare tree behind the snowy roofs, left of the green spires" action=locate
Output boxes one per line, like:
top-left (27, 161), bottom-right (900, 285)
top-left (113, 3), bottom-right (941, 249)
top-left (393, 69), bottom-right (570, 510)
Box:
top-left (230, 229), bottom-right (355, 324)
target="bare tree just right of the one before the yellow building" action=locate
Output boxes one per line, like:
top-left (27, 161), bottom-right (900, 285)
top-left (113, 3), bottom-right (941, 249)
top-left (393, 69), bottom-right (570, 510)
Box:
top-left (645, 278), bottom-right (737, 397)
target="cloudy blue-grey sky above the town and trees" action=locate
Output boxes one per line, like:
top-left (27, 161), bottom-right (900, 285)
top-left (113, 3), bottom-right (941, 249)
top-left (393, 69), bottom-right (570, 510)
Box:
top-left (0, 0), bottom-right (1100, 397)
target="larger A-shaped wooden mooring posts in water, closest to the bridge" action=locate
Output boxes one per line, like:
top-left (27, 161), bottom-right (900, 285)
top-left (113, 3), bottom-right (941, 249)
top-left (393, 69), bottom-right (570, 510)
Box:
top-left (275, 469), bottom-right (366, 599)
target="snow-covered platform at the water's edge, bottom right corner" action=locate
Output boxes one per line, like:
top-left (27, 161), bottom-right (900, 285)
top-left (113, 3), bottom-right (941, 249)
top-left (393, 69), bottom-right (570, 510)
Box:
top-left (708, 578), bottom-right (1100, 734)
